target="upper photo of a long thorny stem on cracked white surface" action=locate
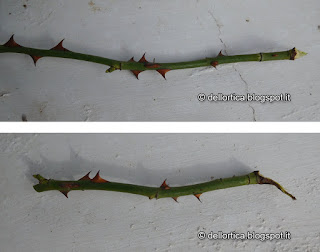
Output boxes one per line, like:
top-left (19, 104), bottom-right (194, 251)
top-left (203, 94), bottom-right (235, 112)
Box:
top-left (0, 0), bottom-right (320, 121)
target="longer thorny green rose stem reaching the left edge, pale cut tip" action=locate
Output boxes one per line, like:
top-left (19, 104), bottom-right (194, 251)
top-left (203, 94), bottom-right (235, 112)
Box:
top-left (0, 36), bottom-right (306, 78)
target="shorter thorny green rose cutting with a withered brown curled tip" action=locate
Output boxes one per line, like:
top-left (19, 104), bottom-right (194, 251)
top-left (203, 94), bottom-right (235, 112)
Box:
top-left (34, 171), bottom-right (296, 200)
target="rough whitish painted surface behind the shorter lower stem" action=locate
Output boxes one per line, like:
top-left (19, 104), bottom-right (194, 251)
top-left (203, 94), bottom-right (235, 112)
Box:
top-left (0, 134), bottom-right (320, 252)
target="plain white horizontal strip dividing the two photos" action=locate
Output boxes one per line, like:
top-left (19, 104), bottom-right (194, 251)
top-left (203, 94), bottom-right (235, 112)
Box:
top-left (0, 122), bottom-right (320, 133)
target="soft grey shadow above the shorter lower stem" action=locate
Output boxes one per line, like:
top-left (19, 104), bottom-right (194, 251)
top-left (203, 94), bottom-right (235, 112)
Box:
top-left (23, 149), bottom-right (253, 186)
